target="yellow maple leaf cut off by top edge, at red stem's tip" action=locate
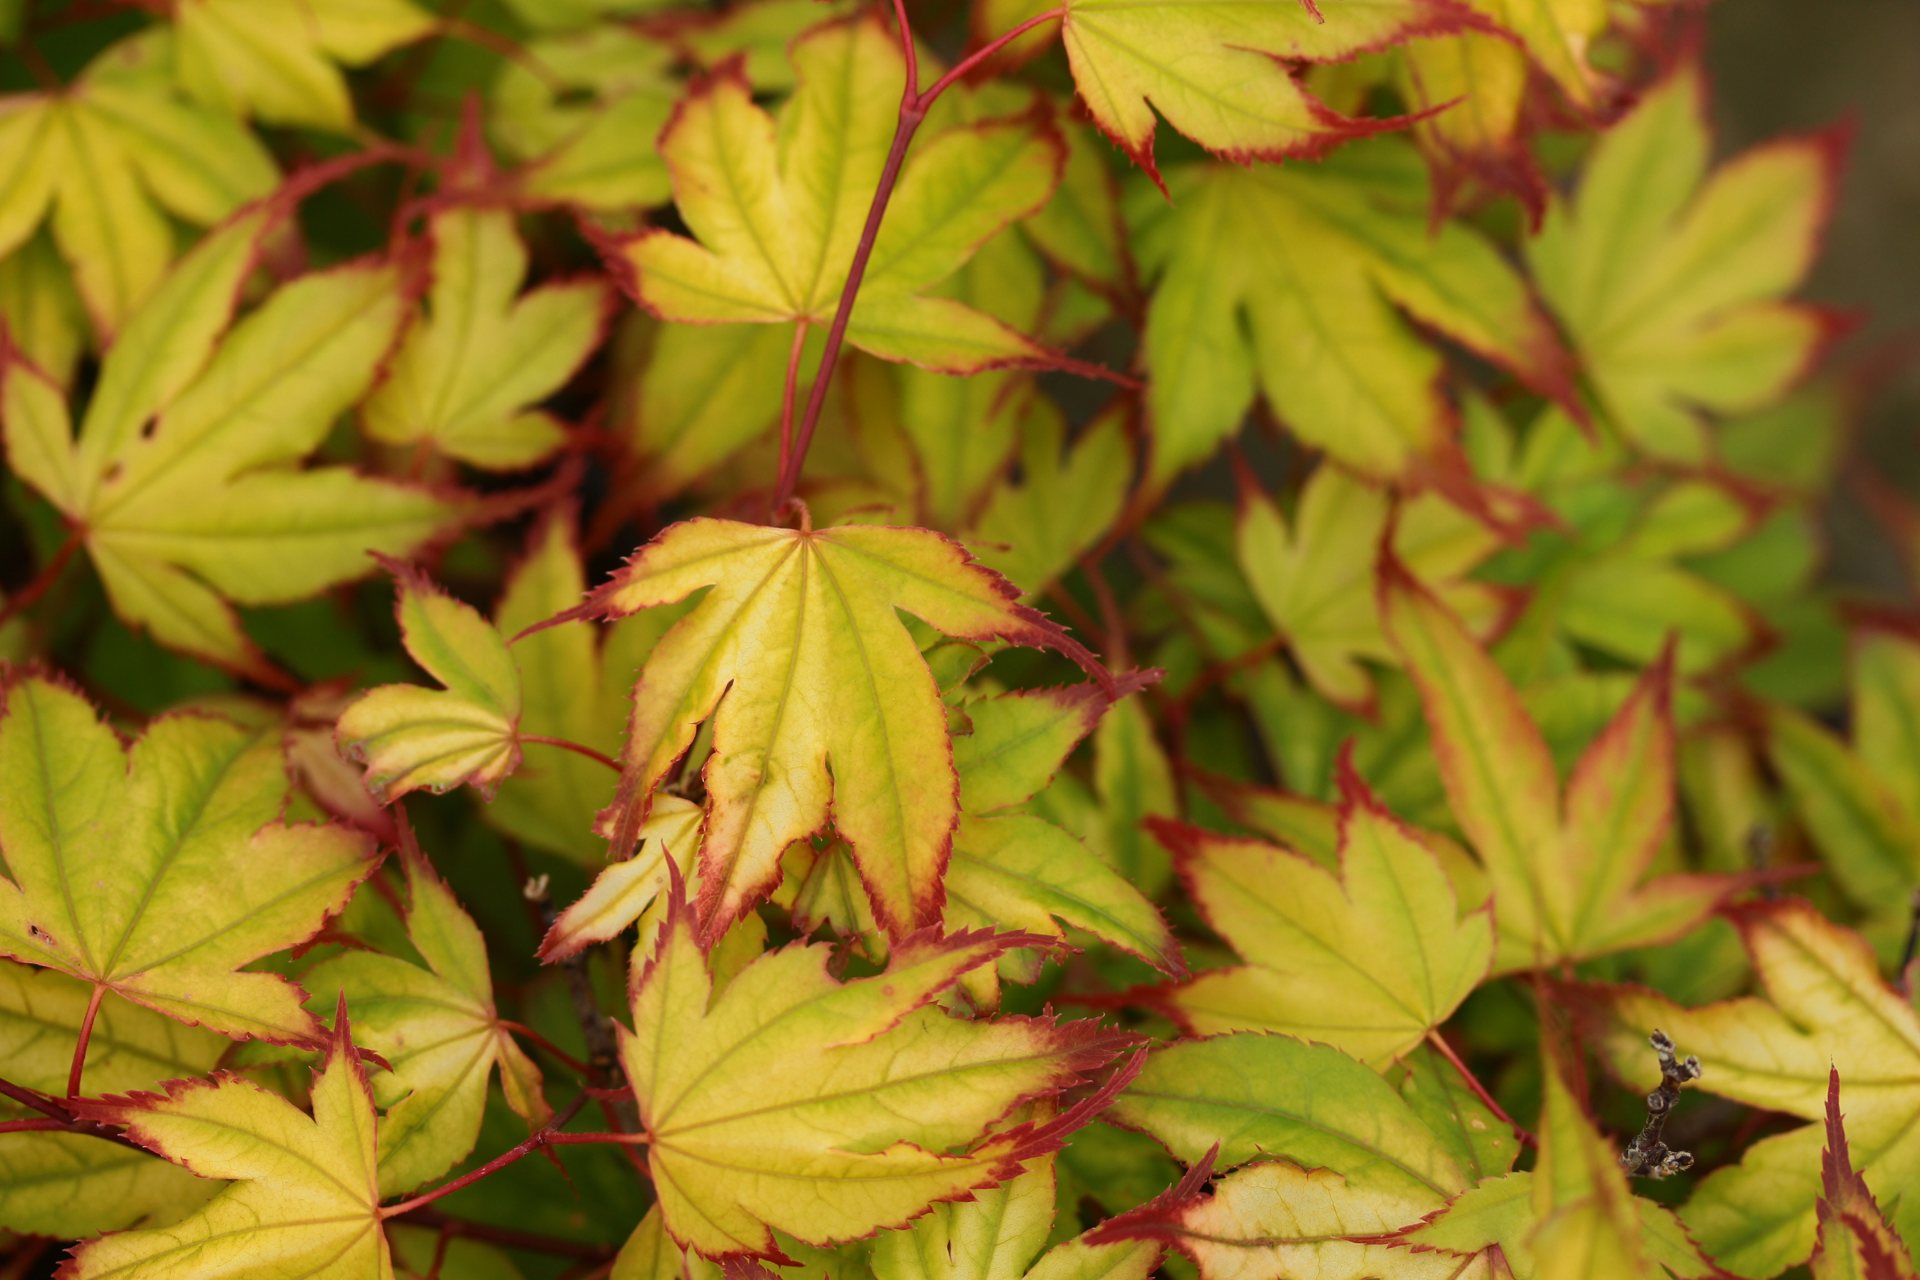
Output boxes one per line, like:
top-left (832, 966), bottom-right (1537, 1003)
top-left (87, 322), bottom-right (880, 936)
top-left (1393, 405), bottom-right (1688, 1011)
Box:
top-left (1060, 0), bottom-right (1473, 180)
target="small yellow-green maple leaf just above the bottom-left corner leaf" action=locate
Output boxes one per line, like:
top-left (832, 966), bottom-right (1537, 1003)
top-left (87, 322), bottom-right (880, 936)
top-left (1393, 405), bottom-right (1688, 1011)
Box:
top-left (305, 852), bottom-right (553, 1196)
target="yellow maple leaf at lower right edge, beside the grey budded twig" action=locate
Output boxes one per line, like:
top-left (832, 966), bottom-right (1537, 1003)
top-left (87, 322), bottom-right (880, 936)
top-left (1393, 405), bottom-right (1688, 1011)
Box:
top-left (1599, 900), bottom-right (1920, 1276)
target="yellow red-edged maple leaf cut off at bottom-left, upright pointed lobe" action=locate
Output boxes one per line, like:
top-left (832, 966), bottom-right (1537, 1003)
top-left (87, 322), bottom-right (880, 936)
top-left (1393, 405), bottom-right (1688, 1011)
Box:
top-left (60, 1009), bottom-right (394, 1280)
